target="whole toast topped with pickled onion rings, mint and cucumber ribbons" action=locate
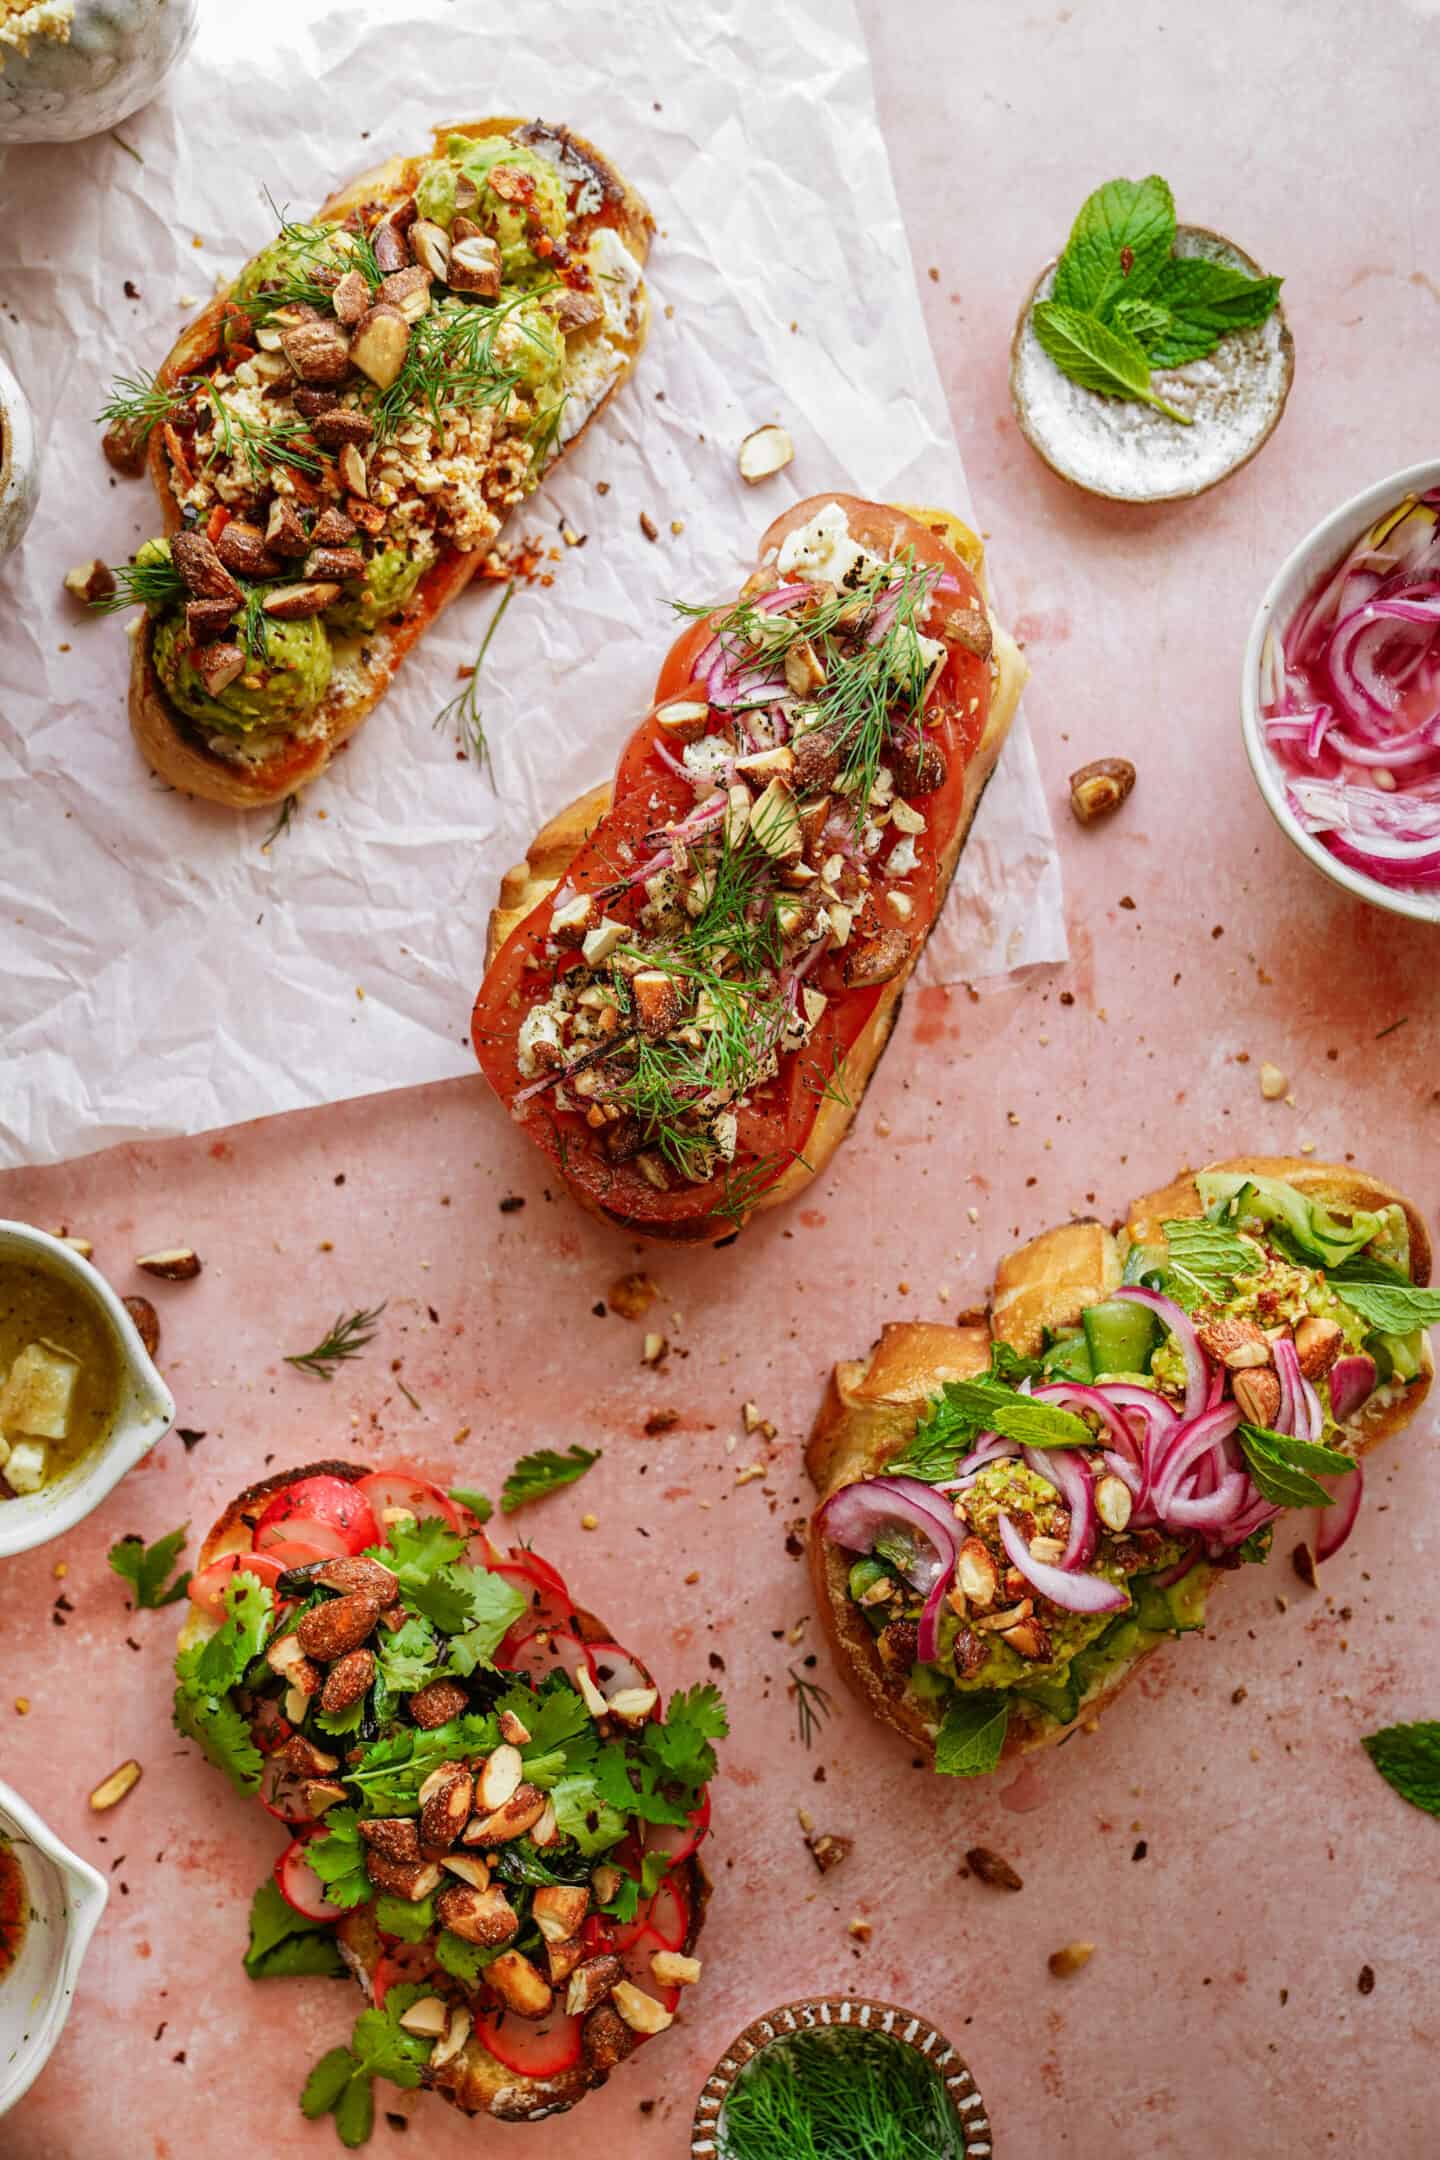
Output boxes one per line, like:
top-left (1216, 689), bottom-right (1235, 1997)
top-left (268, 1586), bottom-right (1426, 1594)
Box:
top-left (805, 1158), bottom-right (1440, 1776)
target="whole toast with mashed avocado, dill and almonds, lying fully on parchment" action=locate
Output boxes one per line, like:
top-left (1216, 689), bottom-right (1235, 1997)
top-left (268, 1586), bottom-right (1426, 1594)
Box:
top-left (106, 119), bottom-right (652, 810)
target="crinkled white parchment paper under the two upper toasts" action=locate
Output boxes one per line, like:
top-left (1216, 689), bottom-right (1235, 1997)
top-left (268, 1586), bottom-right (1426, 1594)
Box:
top-left (0, 0), bottom-right (1064, 1164)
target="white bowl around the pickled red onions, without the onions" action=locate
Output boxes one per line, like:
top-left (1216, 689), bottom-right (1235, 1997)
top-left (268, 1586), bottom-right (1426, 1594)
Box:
top-left (1239, 458), bottom-right (1440, 922)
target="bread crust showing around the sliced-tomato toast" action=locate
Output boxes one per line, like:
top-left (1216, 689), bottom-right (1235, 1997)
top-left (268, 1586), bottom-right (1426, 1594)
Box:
top-left (486, 503), bottom-right (1030, 1244)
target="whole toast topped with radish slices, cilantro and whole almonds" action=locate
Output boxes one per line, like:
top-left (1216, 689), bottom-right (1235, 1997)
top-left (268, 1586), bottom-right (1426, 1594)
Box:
top-left (175, 1462), bottom-right (725, 2143)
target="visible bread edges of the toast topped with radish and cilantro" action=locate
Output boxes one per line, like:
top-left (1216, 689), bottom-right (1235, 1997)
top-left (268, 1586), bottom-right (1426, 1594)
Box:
top-left (179, 1462), bottom-right (710, 2123)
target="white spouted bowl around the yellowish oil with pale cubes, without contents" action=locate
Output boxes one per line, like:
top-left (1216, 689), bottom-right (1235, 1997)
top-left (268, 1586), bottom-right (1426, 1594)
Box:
top-left (0, 1223), bottom-right (175, 1560)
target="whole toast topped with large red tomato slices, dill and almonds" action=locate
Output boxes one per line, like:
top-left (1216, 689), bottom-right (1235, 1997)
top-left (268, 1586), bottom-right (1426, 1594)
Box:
top-left (473, 497), bottom-right (1023, 1240)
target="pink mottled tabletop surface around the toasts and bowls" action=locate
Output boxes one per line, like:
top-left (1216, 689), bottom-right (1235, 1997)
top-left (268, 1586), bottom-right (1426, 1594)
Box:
top-left (0, 0), bottom-right (1440, 2160)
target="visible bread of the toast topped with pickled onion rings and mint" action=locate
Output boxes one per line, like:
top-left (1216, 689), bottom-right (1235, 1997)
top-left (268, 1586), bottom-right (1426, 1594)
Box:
top-left (805, 1156), bottom-right (1434, 1760)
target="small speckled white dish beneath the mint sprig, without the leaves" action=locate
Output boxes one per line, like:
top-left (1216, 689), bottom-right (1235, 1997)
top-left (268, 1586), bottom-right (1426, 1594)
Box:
top-left (1010, 225), bottom-right (1295, 503)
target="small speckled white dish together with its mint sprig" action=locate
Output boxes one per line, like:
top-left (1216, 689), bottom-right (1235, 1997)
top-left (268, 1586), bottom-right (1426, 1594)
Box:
top-left (1010, 173), bottom-right (1295, 503)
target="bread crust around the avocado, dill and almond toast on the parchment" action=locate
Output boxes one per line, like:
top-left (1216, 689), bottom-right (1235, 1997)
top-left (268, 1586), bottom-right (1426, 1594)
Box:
top-left (130, 114), bottom-right (654, 810)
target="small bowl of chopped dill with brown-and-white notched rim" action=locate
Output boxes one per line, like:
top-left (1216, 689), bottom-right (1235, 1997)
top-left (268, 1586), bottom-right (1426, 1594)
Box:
top-left (691, 1996), bottom-right (995, 2160)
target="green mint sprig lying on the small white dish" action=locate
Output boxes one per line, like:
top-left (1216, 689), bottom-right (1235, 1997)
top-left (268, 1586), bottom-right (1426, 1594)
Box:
top-left (1030, 173), bottom-right (1280, 426)
